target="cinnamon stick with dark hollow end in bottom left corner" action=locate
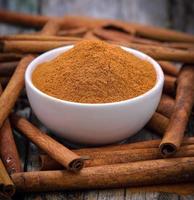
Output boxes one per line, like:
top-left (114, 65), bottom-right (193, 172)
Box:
top-left (0, 159), bottom-right (15, 197)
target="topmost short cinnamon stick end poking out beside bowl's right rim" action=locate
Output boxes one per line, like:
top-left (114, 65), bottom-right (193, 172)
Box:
top-left (158, 61), bottom-right (180, 76)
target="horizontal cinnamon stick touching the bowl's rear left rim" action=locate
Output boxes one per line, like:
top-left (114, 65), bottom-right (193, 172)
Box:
top-left (0, 41), bottom-right (75, 53)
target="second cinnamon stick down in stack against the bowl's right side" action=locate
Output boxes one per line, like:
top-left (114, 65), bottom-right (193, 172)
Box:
top-left (163, 75), bottom-right (176, 96)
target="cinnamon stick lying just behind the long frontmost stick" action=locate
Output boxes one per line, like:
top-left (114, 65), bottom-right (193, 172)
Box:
top-left (40, 138), bottom-right (194, 171)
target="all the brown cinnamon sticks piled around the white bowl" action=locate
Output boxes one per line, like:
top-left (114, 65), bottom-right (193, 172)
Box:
top-left (0, 10), bottom-right (194, 196)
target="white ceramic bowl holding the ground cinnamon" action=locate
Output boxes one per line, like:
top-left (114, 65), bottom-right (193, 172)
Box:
top-left (25, 46), bottom-right (164, 145)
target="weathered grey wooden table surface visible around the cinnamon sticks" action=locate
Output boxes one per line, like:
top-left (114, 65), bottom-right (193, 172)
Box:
top-left (0, 0), bottom-right (194, 200)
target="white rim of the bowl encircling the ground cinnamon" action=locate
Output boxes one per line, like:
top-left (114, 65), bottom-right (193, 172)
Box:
top-left (25, 45), bottom-right (164, 107)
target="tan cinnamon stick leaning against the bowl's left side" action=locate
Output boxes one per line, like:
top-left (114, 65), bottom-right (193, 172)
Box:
top-left (0, 55), bottom-right (34, 127)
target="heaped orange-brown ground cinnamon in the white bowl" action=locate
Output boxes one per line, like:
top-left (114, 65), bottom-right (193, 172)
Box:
top-left (32, 40), bottom-right (156, 103)
